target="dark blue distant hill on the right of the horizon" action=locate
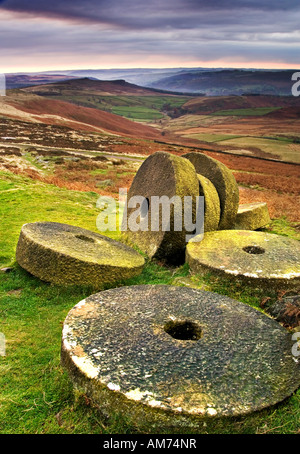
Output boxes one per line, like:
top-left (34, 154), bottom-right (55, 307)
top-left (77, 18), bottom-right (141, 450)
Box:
top-left (150, 69), bottom-right (295, 96)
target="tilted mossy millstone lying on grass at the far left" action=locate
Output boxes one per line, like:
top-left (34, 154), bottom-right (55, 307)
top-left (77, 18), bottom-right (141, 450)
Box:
top-left (16, 222), bottom-right (144, 288)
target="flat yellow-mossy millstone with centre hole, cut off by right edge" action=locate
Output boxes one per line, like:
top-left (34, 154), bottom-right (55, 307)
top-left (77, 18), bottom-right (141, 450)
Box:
top-left (186, 230), bottom-right (300, 288)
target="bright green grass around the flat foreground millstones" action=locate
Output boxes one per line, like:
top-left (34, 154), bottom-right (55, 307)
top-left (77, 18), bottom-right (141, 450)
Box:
top-left (0, 172), bottom-right (300, 434)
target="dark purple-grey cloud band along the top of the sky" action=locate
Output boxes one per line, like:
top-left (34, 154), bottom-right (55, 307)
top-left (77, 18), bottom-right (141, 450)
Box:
top-left (2, 0), bottom-right (300, 29)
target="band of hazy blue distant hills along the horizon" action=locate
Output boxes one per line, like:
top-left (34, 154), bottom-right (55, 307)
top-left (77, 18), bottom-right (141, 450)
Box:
top-left (6, 67), bottom-right (297, 96)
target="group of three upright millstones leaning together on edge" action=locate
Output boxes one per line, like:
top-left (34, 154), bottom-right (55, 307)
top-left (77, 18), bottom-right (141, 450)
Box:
top-left (123, 152), bottom-right (239, 264)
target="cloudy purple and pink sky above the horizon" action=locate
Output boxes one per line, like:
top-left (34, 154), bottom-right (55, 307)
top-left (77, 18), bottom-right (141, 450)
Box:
top-left (0, 0), bottom-right (300, 73)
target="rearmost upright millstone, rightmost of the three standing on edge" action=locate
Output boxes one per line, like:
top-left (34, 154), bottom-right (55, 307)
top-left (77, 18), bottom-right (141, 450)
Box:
top-left (183, 153), bottom-right (239, 230)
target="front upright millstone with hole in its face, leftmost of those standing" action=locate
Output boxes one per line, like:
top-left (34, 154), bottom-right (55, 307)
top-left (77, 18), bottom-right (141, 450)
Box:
top-left (122, 151), bottom-right (199, 264)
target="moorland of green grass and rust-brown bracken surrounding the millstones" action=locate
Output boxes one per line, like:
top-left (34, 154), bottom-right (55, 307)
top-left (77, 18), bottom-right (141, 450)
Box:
top-left (0, 80), bottom-right (300, 434)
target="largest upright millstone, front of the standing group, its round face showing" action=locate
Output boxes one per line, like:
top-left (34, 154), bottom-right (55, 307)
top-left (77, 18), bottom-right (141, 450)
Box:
top-left (123, 151), bottom-right (199, 263)
